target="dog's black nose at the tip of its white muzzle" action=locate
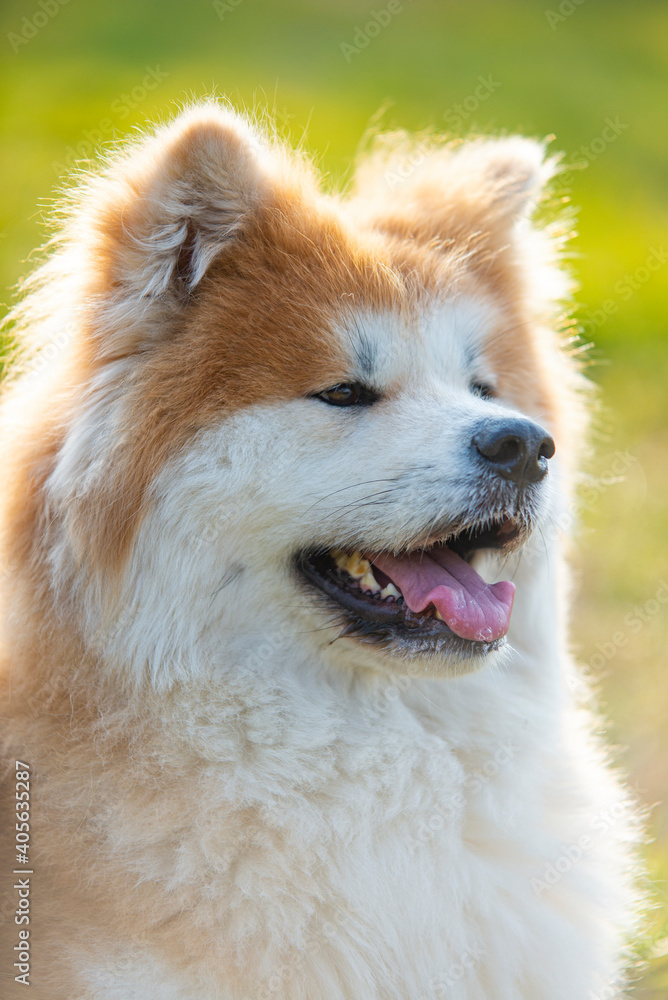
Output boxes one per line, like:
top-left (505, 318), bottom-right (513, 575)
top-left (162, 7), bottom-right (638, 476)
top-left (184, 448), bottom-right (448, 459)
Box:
top-left (471, 419), bottom-right (554, 486)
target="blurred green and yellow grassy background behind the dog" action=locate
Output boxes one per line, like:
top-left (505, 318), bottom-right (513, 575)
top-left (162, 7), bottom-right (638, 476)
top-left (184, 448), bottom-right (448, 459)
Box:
top-left (0, 0), bottom-right (668, 998)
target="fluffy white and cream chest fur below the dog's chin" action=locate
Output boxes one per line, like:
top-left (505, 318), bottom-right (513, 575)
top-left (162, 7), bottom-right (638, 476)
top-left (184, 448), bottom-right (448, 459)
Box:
top-left (35, 616), bottom-right (627, 1000)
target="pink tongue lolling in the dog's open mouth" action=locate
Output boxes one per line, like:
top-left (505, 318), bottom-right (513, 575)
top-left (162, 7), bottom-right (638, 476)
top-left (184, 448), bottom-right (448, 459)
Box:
top-left (373, 546), bottom-right (515, 642)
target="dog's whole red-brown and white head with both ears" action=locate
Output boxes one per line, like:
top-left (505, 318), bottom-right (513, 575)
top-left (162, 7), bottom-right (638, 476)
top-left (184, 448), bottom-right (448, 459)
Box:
top-left (10, 106), bottom-right (575, 688)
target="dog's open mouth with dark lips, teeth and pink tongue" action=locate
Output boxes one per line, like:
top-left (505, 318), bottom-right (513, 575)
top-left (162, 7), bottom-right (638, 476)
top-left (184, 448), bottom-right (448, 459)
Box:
top-left (298, 518), bottom-right (526, 656)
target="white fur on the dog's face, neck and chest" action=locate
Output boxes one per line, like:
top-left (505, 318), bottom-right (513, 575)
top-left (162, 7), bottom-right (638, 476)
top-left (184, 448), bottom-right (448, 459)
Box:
top-left (43, 301), bottom-right (635, 1000)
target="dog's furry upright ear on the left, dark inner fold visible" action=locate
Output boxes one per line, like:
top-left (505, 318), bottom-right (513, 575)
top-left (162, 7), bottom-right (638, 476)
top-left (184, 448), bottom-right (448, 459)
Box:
top-left (85, 103), bottom-right (265, 308)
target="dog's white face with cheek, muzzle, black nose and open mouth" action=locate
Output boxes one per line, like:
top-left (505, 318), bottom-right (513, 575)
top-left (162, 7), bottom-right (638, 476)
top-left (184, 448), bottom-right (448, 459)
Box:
top-left (190, 290), bottom-right (554, 669)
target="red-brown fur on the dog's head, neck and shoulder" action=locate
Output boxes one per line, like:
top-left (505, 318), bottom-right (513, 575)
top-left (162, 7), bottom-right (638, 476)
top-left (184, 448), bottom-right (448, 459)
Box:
top-left (0, 105), bottom-right (596, 1000)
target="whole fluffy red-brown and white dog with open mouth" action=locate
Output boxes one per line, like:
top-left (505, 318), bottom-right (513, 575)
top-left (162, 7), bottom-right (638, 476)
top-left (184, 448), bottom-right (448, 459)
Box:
top-left (0, 102), bottom-right (642, 1000)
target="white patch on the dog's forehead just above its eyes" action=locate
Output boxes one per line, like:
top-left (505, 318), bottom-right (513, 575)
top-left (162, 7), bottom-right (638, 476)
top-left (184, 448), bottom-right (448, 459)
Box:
top-left (342, 293), bottom-right (501, 388)
